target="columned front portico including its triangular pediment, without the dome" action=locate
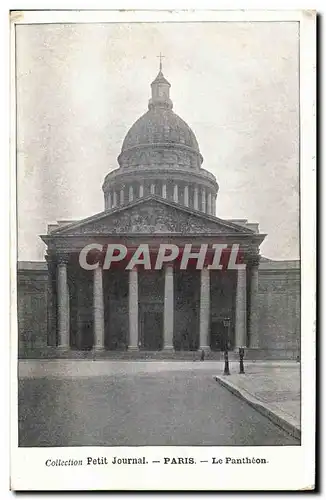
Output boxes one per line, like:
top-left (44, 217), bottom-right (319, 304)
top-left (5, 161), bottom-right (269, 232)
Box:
top-left (43, 196), bottom-right (262, 352)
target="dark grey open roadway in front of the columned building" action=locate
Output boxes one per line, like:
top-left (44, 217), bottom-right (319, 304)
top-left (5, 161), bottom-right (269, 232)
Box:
top-left (19, 360), bottom-right (299, 446)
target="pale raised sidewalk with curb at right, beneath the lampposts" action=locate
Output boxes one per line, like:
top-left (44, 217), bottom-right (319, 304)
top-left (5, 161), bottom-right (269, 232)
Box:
top-left (215, 361), bottom-right (301, 439)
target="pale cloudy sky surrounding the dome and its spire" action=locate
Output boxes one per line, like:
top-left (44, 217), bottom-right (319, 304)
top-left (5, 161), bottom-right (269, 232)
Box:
top-left (16, 22), bottom-right (299, 261)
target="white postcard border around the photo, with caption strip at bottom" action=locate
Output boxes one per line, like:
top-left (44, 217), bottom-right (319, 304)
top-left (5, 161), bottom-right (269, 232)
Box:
top-left (10, 11), bottom-right (316, 490)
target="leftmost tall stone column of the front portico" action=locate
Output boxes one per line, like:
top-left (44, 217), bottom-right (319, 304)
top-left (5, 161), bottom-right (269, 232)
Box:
top-left (57, 256), bottom-right (70, 349)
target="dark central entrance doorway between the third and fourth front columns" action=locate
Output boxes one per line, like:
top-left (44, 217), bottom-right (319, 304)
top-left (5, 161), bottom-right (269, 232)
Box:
top-left (140, 311), bottom-right (163, 351)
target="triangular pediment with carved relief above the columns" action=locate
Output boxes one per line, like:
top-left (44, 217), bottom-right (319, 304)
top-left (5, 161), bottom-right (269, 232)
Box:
top-left (51, 196), bottom-right (253, 236)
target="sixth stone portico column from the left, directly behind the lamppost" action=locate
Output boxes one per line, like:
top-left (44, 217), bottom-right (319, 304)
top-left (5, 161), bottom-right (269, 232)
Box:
top-left (235, 269), bottom-right (247, 348)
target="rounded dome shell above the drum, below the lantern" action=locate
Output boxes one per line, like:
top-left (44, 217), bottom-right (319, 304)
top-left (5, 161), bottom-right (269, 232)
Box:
top-left (121, 106), bottom-right (199, 153)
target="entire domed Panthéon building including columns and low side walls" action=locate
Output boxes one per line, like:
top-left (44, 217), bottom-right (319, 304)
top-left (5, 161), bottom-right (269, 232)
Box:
top-left (18, 68), bottom-right (300, 359)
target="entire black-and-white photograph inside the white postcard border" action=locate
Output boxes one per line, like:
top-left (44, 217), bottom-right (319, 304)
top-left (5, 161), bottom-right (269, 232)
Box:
top-left (15, 17), bottom-right (301, 452)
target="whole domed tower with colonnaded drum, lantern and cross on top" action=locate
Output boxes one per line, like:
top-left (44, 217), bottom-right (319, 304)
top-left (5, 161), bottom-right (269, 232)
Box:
top-left (102, 62), bottom-right (218, 215)
